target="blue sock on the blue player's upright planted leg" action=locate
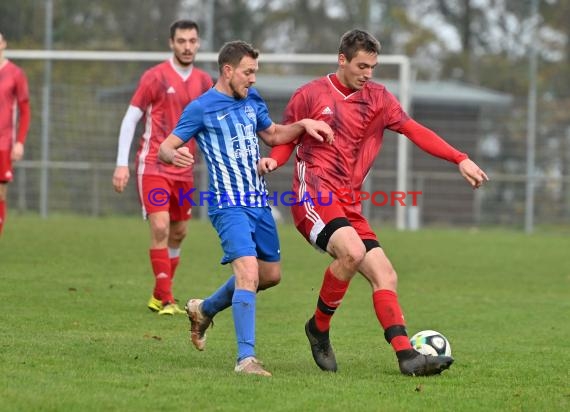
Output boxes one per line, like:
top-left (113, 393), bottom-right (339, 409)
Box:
top-left (232, 289), bottom-right (255, 362)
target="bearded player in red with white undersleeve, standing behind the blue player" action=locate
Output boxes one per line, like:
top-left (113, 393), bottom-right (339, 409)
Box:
top-left (113, 20), bottom-right (213, 315)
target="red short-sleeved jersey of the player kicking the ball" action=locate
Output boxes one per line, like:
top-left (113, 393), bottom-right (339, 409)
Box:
top-left (283, 76), bottom-right (409, 197)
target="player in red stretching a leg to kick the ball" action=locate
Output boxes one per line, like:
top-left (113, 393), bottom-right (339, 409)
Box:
top-left (260, 30), bottom-right (488, 376)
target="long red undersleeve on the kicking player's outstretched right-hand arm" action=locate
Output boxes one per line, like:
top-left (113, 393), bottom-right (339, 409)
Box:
top-left (396, 119), bottom-right (468, 164)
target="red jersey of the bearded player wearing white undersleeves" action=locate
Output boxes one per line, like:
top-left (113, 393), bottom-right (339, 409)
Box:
top-left (131, 60), bottom-right (213, 181)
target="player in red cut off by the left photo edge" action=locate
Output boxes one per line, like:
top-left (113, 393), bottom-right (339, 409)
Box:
top-left (0, 33), bottom-right (30, 236)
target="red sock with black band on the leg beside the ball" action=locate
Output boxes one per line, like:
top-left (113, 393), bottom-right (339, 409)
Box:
top-left (372, 289), bottom-right (412, 352)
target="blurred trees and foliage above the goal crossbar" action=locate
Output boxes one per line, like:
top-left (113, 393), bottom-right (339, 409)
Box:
top-left (0, 0), bottom-right (570, 97)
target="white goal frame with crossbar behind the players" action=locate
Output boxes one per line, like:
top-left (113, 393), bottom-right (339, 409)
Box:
top-left (5, 50), bottom-right (411, 230)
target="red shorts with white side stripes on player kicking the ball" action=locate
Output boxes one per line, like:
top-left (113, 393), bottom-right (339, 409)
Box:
top-left (291, 197), bottom-right (378, 249)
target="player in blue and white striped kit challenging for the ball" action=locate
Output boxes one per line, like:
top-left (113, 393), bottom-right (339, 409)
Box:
top-left (159, 41), bottom-right (333, 376)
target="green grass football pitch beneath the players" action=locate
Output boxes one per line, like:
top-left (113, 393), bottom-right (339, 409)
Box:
top-left (0, 217), bottom-right (570, 411)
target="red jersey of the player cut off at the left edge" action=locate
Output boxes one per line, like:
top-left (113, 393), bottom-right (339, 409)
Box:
top-left (0, 60), bottom-right (30, 150)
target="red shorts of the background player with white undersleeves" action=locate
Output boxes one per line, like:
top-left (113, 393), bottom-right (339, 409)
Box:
top-left (137, 175), bottom-right (194, 222)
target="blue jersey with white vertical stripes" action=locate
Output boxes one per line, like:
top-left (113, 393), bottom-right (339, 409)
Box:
top-left (172, 88), bottom-right (273, 208)
